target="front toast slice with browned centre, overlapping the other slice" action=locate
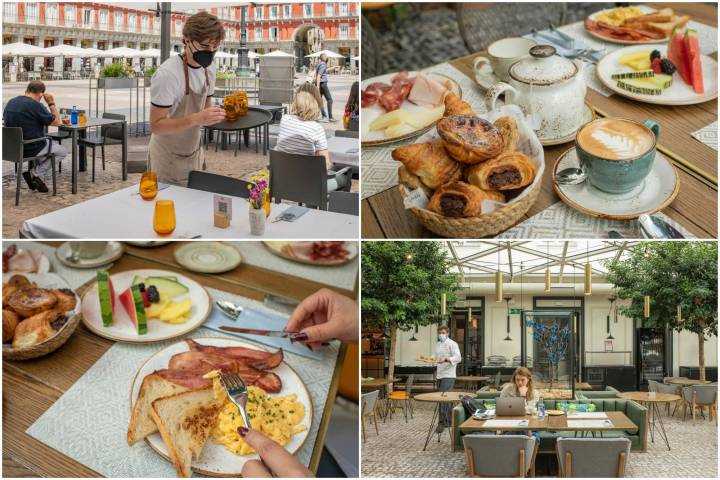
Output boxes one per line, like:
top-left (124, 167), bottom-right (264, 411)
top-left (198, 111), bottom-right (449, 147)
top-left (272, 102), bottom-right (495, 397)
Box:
top-left (152, 387), bottom-right (223, 477)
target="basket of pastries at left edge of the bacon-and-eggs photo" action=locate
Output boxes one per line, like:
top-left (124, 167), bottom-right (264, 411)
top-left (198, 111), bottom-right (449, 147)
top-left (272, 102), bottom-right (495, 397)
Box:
top-left (2, 273), bottom-right (80, 360)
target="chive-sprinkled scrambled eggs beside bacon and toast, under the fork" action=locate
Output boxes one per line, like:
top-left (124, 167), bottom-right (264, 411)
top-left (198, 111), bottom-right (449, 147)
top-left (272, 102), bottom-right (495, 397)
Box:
top-left (205, 371), bottom-right (306, 455)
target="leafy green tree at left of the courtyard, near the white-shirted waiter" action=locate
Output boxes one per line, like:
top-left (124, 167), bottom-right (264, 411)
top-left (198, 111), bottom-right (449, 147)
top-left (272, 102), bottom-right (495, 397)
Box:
top-left (362, 242), bottom-right (459, 388)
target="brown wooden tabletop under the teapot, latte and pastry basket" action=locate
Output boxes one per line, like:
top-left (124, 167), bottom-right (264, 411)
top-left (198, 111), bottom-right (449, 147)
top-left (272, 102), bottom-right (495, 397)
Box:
top-left (362, 4), bottom-right (718, 238)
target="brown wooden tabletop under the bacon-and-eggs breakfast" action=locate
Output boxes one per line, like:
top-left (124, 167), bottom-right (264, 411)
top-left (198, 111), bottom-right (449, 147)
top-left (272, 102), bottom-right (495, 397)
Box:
top-left (2, 242), bottom-right (356, 477)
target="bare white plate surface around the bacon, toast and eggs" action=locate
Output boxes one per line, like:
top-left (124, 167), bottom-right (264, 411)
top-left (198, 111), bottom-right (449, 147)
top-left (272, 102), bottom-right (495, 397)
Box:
top-left (130, 337), bottom-right (313, 477)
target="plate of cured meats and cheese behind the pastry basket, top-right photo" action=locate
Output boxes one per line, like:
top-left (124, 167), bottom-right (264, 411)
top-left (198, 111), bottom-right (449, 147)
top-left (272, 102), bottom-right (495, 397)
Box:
top-left (360, 71), bottom-right (462, 147)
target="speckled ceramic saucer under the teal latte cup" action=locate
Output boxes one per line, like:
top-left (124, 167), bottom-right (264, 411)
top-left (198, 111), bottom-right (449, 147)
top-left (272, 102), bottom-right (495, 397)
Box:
top-left (552, 147), bottom-right (680, 220)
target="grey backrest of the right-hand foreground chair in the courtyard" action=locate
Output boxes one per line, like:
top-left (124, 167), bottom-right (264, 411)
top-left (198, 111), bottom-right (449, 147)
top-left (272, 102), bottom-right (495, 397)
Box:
top-left (556, 437), bottom-right (631, 478)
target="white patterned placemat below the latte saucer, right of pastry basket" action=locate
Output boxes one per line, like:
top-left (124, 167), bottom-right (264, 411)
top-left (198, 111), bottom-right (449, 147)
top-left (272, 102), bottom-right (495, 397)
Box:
top-left (495, 202), bottom-right (695, 238)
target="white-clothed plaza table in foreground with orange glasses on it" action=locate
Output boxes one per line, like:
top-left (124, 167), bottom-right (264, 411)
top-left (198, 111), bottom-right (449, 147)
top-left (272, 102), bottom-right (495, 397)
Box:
top-left (20, 184), bottom-right (359, 240)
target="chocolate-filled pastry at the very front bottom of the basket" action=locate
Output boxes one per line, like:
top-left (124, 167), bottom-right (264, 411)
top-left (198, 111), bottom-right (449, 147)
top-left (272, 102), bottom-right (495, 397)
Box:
top-left (427, 182), bottom-right (505, 218)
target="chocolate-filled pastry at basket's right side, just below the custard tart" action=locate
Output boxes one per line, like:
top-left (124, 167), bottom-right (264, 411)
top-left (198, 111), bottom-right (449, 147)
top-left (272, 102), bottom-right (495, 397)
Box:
top-left (466, 152), bottom-right (535, 190)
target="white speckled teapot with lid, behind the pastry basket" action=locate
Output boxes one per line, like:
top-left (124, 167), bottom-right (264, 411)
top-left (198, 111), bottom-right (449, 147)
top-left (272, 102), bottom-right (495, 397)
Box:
top-left (485, 45), bottom-right (587, 140)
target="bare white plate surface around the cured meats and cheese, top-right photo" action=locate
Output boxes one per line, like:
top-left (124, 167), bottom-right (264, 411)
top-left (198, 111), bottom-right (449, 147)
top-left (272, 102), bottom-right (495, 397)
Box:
top-left (360, 72), bottom-right (462, 147)
